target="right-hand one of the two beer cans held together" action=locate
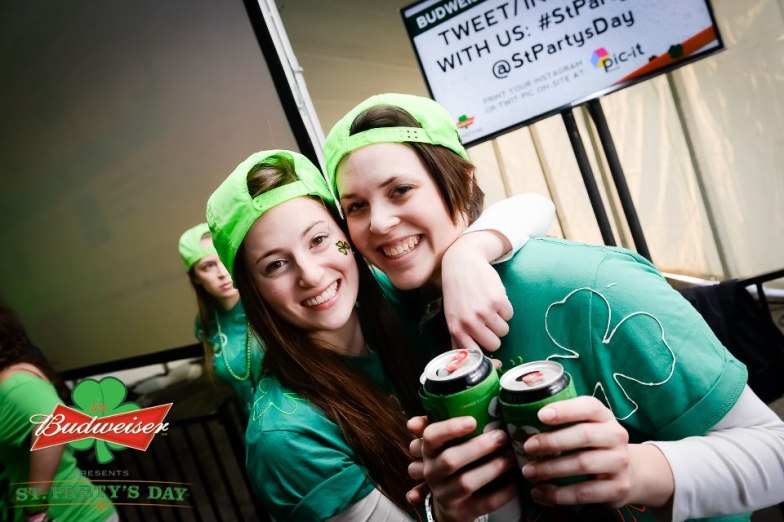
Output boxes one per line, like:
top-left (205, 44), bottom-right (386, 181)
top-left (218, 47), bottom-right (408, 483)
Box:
top-left (498, 361), bottom-right (577, 467)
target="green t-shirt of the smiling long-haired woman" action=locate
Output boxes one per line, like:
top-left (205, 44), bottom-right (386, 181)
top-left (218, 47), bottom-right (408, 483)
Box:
top-left (245, 353), bottom-right (390, 522)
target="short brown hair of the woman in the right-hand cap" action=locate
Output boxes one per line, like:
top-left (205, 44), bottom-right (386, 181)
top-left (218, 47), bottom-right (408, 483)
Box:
top-left (349, 105), bottom-right (485, 223)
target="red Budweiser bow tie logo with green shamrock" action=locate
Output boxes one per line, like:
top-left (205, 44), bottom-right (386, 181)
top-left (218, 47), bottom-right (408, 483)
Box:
top-left (30, 377), bottom-right (172, 464)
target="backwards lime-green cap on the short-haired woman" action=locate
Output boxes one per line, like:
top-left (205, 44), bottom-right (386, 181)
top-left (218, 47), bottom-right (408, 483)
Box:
top-left (324, 93), bottom-right (469, 193)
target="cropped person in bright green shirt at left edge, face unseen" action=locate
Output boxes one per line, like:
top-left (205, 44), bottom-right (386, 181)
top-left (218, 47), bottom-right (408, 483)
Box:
top-left (0, 304), bottom-right (118, 522)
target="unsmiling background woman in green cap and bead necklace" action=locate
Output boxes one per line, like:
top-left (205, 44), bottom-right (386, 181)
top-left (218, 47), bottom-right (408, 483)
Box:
top-left (179, 223), bottom-right (264, 419)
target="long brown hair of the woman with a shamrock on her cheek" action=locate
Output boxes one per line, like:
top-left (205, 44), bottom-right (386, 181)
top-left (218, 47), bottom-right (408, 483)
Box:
top-left (234, 156), bottom-right (421, 509)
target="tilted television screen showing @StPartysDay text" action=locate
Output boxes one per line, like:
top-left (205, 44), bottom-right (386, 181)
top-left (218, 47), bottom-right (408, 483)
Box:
top-left (401, 0), bottom-right (723, 145)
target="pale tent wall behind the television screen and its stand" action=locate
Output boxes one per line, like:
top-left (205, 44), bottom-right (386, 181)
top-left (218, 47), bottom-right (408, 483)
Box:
top-left (277, 0), bottom-right (784, 279)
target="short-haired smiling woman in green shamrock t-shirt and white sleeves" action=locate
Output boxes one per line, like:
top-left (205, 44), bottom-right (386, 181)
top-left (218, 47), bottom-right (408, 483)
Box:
top-left (324, 94), bottom-right (784, 522)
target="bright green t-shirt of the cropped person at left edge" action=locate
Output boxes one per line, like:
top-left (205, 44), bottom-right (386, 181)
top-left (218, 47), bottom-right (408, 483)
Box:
top-left (0, 372), bottom-right (114, 522)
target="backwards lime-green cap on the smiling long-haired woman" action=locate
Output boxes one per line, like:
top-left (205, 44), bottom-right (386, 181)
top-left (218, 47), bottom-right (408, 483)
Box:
top-left (207, 150), bottom-right (335, 277)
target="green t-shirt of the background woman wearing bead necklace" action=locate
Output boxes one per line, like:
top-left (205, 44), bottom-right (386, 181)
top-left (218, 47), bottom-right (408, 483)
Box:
top-left (194, 301), bottom-right (264, 417)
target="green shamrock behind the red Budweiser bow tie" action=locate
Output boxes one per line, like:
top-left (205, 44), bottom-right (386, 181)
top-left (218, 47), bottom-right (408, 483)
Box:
top-left (68, 377), bottom-right (140, 464)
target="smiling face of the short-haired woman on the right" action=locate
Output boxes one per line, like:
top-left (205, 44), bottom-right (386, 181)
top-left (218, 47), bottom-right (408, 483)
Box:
top-left (337, 139), bottom-right (472, 290)
